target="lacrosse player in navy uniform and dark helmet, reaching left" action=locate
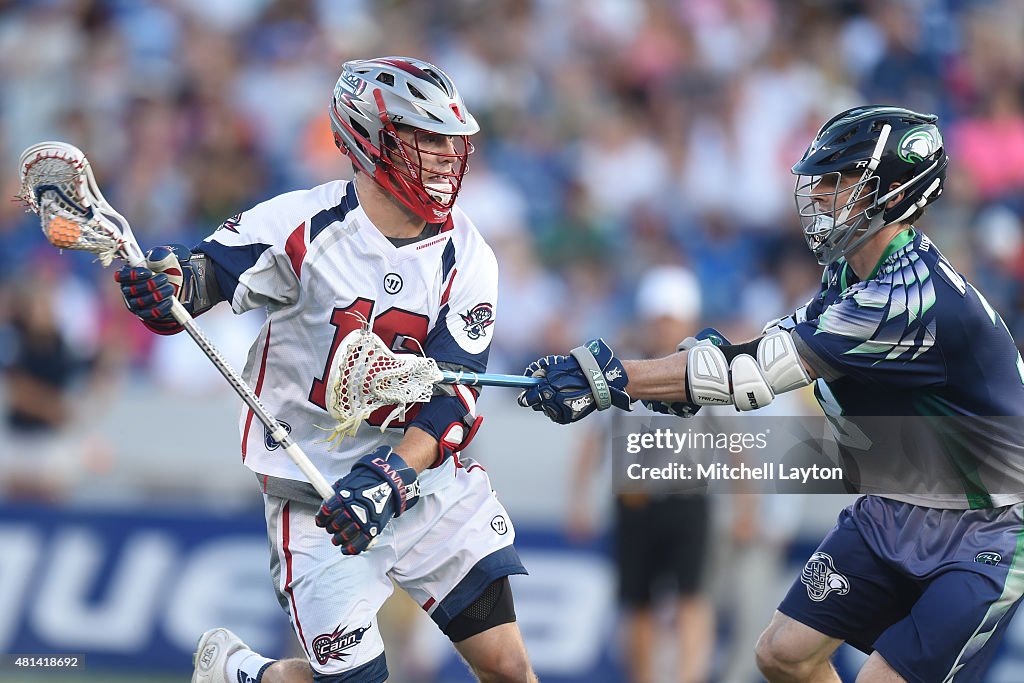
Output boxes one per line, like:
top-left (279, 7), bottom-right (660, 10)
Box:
top-left (520, 106), bottom-right (1024, 683)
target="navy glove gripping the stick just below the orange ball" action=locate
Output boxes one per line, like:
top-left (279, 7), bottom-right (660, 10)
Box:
top-left (114, 245), bottom-right (191, 335)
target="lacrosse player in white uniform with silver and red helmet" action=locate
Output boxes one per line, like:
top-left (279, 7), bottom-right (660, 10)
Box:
top-left (117, 57), bottom-right (536, 683)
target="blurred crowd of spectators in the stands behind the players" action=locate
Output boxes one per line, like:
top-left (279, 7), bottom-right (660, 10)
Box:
top-left (0, 0), bottom-right (1024, 385)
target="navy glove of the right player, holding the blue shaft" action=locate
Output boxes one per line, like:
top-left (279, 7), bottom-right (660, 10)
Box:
top-left (519, 339), bottom-right (631, 425)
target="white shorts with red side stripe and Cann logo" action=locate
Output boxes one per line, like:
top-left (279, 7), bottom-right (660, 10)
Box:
top-left (263, 460), bottom-right (526, 683)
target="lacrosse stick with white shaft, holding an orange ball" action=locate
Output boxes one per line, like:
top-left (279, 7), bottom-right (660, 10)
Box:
top-left (18, 141), bottom-right (334, 500)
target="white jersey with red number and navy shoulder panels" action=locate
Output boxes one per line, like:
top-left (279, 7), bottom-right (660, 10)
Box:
top-left (198, 180), bottom-right (498, 493)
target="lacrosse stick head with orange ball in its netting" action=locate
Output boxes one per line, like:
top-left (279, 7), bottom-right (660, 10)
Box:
top-left (17, 141), bottom-right (145, 266)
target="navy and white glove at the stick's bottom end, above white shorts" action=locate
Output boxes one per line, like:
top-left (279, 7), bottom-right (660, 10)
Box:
top-left (316, 445), bottom-right (420, 555)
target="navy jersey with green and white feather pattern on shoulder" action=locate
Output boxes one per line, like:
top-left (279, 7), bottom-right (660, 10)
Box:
top-left (794, 229), bottom-right (1024, 508)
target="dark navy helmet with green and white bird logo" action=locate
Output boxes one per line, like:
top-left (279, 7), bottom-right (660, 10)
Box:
top-left (793, 105), bottom-right (949, 265)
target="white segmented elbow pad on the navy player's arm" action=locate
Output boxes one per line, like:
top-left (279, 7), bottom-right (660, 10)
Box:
top-left (686, 331), bottom-right (811, 411)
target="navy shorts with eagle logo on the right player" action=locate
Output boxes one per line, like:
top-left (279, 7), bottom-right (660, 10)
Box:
top-left (778, 496), bottom-right (1024, 683)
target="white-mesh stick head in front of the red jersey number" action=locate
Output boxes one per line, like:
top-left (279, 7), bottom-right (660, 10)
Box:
top-left (327, 324), bottom-right (441, 441)
